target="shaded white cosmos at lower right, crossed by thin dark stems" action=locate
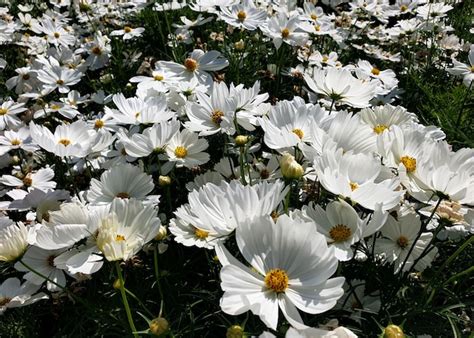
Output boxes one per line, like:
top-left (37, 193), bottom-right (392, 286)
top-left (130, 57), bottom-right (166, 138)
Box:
top-left (375, 212), bottom-right (438, 273)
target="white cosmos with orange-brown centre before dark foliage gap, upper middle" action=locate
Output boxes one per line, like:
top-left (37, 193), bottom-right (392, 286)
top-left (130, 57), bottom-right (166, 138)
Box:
top-left (159, 49), bottom-right (229, 86)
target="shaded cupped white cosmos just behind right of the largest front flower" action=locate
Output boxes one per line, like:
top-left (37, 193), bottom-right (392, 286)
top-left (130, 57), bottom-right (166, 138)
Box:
top-left (302, 201), bottom-right (388, 261)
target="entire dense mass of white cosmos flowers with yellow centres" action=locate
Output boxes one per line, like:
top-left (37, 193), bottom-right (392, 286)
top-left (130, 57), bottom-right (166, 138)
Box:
top-left (0, 0), bottom-right (474, 337)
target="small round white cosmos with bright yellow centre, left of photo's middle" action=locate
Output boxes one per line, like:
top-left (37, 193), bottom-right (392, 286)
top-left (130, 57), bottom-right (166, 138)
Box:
top-left (166, 129), bottom-right (210, 168)
